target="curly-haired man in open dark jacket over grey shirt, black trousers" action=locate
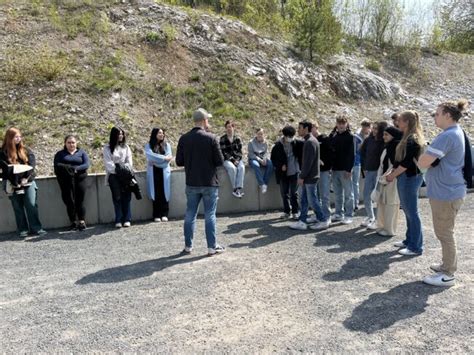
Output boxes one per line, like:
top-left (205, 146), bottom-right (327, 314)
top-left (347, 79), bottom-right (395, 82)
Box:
top-left (270, 126), bottom-right (303, 219)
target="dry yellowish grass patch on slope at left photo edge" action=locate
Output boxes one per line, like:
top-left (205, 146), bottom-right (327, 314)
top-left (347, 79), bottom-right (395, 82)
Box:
top-left (0, 47), bottom-right (68, 85)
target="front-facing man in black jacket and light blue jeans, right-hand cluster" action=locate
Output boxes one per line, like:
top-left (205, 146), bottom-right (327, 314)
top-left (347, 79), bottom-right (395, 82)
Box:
top-left (331, 116), bottom-right (355, 224)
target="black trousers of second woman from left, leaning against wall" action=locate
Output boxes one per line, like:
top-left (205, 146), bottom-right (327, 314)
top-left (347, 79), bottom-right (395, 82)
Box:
top-left (57, 174), bottom-right (87, 223)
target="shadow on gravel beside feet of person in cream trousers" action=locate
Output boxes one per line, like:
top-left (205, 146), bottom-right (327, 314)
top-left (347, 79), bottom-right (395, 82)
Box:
top-left (314, 227), bottom-right (388, 253)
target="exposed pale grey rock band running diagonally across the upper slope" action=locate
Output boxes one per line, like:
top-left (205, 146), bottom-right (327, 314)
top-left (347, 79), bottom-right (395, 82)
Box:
top-left (110, 0), bottom-right (404, 100)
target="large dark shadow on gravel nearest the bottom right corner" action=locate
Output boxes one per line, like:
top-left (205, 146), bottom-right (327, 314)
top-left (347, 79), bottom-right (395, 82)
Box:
top-left (343, 281), bottom-right (445, 334)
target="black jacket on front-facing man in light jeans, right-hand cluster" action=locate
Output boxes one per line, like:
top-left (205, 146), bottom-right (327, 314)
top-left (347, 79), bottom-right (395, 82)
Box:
top-left (330, 130), bottom-right (355, 172)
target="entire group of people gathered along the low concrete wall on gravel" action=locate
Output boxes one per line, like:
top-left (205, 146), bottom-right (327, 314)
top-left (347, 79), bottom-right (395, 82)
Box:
top-left (0, 101), bottom-right (472, 286)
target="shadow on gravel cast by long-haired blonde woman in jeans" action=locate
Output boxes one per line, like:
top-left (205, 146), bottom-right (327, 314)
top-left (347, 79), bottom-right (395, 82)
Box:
top-left (323, 250), bottom-right (411, 281)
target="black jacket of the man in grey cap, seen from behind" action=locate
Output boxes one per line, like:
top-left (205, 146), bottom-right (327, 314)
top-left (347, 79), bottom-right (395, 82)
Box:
top-left (176, 127), bottom-right (224, 186)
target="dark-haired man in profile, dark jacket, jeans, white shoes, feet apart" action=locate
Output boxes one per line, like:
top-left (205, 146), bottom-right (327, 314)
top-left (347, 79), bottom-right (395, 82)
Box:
top-left (290, 121), bottom-right (329, 230)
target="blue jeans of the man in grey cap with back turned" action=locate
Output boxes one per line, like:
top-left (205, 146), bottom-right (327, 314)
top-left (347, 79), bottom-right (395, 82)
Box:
top-left (184, 186), bottom-right (219, 248)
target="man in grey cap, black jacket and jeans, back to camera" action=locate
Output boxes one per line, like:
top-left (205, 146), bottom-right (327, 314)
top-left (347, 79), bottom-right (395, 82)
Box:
top-left (176, 108), bottom-right (225, 256)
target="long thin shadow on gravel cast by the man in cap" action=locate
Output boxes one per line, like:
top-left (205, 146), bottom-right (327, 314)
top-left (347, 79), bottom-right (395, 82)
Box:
top-left (76, 253), bottom-right (208, 285)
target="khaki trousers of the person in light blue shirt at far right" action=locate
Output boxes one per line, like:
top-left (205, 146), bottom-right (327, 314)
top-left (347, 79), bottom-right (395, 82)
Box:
top-left (430, 198), bottom-right (464, 276)
